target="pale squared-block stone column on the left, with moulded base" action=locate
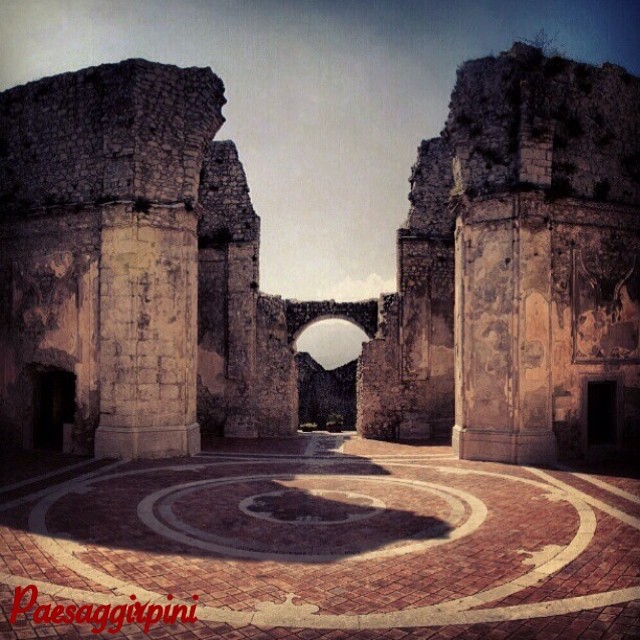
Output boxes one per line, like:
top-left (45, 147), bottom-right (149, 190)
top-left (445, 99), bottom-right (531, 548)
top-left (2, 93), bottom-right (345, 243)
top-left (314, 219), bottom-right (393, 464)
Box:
top-left (95, 204), bottom-right (200, 458)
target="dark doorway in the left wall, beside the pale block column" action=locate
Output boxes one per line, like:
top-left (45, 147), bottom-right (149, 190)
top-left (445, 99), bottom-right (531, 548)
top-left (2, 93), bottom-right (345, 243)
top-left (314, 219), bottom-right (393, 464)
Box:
top-left (33, 371), bottom-right (76, 451)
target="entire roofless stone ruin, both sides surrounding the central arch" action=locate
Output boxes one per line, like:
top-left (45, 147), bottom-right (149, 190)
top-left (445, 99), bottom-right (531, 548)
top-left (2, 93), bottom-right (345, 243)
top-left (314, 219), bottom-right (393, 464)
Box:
top-left (0, 45), bottom-right (640, 463)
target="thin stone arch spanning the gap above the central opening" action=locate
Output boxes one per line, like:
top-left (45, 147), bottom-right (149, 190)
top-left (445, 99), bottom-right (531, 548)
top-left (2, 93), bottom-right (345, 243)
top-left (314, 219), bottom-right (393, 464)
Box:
top-left (286, 299), bottom-right (378, 345)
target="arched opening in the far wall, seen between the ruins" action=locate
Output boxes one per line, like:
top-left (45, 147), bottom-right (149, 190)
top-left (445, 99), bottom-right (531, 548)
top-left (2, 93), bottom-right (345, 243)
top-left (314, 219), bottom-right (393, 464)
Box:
top-left (295, 318), bottom-right (369, 431)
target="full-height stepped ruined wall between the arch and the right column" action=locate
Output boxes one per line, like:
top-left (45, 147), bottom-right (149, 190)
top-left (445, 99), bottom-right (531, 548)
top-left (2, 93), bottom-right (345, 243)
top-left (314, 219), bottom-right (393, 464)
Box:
top-left (357, 139), bottom-right (455, 439)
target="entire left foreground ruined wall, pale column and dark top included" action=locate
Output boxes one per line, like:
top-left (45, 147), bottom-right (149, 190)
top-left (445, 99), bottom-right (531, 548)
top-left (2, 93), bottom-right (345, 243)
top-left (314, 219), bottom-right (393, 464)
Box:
top-left (0, 60), bottom-right (224, 457)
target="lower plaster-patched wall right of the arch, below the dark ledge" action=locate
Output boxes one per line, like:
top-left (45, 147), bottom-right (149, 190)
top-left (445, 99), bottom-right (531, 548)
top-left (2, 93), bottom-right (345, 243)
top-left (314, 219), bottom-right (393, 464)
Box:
top-left (357, 237), bottom-right (454, 440)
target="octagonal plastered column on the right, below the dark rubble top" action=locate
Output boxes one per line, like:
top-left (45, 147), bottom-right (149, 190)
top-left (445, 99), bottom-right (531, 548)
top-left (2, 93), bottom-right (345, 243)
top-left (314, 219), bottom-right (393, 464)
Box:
top-left (453, 195), bottom-right (555, 464)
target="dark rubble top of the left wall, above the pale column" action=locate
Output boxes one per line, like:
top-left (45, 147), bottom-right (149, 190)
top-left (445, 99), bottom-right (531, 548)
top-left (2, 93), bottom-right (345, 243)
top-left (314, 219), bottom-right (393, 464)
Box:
top-left (0, 59), bottom-right (225, 212)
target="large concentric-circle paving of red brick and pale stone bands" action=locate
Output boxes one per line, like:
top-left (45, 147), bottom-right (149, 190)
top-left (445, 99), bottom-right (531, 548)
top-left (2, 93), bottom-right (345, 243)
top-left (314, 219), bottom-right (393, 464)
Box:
top-left (1, 442), bottom-right (640, 629)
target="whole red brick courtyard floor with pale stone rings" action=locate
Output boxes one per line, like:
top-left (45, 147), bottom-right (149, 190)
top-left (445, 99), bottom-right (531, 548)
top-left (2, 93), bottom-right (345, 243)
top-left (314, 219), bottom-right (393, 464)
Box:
top-left (0, 434), bottom-right (640, 640)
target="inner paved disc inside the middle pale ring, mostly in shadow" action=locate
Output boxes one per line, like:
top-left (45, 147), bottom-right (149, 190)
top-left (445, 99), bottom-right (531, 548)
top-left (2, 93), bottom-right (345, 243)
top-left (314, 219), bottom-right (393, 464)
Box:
top-left (138, 474), bottom-right (486, 562)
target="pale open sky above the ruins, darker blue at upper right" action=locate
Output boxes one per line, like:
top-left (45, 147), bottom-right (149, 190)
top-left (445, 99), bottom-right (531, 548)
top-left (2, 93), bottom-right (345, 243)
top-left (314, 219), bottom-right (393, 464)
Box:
top-left (0, 0), bottom-right (640, 366)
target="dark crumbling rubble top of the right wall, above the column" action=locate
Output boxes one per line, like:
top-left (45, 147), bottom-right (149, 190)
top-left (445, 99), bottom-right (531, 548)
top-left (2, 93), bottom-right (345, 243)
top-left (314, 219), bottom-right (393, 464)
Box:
top-left (443, 43), bottom-right (640, 204)
